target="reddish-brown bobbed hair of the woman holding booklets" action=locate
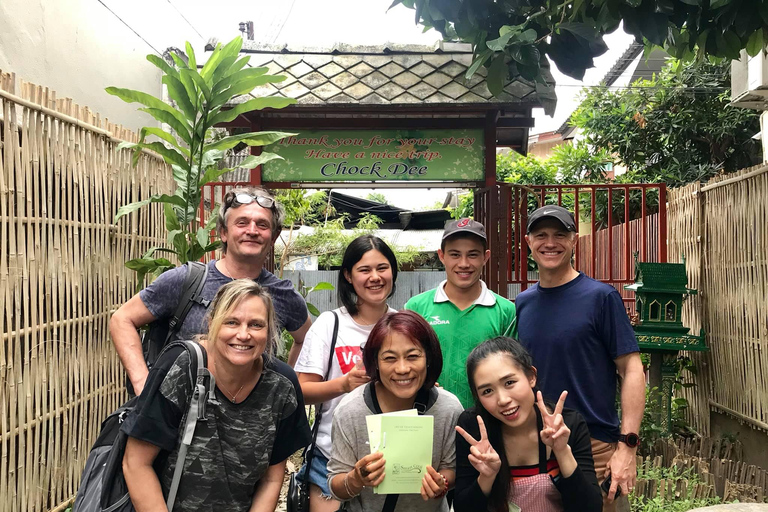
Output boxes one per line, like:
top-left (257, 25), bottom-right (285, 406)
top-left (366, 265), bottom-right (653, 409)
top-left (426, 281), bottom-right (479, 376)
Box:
top-left (363, 310), bottom-right (443, 389)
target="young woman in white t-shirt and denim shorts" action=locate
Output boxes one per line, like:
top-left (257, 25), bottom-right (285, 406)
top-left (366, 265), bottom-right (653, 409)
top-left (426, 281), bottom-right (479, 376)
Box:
top-left (295, 235), bottom-right (397, 512)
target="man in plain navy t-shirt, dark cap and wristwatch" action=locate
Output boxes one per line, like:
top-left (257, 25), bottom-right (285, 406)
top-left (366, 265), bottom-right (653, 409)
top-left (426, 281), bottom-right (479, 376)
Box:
top-left (515, 206), bottom-right (645, 511)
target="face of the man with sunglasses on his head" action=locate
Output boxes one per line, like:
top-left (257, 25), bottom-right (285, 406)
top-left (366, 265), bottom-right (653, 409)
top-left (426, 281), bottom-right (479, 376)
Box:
top-left (221, 202), bottom-right (273, 260)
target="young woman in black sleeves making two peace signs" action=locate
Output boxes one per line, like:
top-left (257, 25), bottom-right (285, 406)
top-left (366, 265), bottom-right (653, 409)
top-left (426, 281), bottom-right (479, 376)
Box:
top-left (454, 337), bottom-right (603, 512)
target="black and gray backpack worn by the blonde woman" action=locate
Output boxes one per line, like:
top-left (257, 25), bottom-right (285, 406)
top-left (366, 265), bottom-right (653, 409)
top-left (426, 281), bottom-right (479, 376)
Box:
top-left (72, 341), bottom-right (216, 512)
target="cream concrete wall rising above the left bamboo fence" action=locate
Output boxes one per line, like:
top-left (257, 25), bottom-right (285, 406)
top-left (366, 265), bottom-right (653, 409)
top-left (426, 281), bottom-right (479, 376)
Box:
top-left (0, 0), bottom-right (165, 130)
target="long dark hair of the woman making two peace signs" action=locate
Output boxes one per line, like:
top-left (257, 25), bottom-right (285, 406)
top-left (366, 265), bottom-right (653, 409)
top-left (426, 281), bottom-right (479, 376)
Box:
top-left (467, 336), bottom-right (536, 512)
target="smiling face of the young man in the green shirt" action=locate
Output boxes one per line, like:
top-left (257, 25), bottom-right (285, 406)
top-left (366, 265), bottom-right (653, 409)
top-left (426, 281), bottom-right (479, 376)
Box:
top-left (437, 237), bottom-right (491, 290)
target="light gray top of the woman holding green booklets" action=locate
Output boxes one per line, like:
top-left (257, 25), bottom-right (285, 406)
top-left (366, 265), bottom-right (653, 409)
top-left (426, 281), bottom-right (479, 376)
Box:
top-left (328, 383), bottom-right (464, 512)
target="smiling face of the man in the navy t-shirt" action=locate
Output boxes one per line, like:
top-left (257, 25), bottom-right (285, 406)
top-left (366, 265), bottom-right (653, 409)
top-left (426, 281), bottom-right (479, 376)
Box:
top-left (525, 219), bottom-right (576, 272)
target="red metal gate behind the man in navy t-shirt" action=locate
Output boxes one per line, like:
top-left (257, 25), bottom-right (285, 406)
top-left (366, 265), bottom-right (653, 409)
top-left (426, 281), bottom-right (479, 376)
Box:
top-left (475, 183), bottom-right (667, 309)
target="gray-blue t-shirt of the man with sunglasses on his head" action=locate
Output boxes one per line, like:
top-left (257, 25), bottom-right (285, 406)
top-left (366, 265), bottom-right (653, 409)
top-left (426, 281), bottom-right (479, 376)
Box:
top-left (139, 260), bottom-right (309, 340)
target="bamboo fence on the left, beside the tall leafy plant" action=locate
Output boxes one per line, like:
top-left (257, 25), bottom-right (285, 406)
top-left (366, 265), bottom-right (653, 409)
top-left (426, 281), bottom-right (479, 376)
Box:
top-left (0, 72), bottom-right (172, 512)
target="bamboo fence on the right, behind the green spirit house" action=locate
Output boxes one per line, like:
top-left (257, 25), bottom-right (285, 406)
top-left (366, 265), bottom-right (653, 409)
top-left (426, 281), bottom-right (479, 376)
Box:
top-left (668, 165), bottom-right (768, 434)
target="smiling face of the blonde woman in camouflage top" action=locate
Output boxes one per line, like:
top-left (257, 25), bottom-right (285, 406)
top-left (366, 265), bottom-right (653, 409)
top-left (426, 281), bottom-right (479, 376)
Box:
top-left (213, 297), bottom-right (269, 366)
